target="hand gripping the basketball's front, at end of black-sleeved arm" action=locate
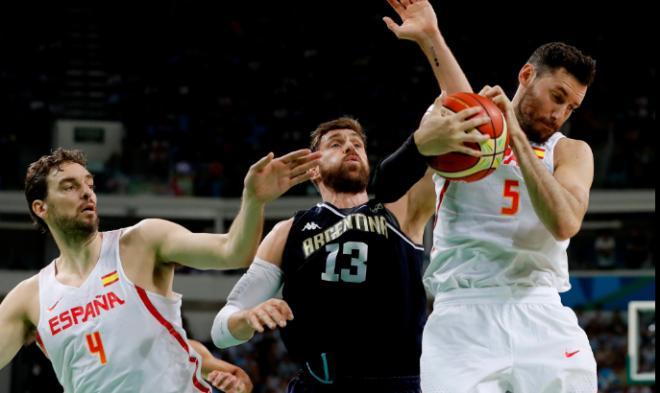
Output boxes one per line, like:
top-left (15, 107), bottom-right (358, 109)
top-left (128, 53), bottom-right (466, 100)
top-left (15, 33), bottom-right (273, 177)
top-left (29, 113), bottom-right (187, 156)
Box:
top-left (414, 97), bottom-right (490, 157)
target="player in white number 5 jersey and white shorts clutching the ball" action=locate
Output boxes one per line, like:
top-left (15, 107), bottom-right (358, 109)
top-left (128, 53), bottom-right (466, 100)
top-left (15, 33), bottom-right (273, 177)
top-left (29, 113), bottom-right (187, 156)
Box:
top-left (380, 0), bottom-right (597, 393)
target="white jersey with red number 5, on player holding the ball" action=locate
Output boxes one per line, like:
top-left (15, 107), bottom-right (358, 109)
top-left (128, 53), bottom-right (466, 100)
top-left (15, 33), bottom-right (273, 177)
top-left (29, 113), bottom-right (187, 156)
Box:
top-left (424, 132), bottom-right (570, 295)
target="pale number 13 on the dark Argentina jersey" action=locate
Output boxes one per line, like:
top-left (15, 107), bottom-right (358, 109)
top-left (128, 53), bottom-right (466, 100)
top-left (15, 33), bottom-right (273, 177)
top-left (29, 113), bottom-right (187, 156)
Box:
top-left (321, 242), bottom-right (369, 283)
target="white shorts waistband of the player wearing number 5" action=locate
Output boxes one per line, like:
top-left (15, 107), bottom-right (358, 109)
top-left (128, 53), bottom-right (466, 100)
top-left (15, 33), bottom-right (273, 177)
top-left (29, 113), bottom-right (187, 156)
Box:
top-left (433, 287), bottom-right (561, 305)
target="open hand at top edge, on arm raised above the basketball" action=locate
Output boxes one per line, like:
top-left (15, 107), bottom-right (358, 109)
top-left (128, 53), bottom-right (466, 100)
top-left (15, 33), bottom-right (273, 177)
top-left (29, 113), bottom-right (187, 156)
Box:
top-left (383, 0), bottom-right (438, 42)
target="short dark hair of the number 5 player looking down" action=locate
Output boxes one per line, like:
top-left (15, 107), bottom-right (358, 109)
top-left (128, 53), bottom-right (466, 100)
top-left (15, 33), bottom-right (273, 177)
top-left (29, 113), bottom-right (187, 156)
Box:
top-left (527, 42), bottom-right (596, 87)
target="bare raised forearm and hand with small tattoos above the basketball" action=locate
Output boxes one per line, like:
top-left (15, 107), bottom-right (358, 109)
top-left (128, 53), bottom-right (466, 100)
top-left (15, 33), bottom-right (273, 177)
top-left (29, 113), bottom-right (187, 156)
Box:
top-left (383, 0), bottom-right (472, 93)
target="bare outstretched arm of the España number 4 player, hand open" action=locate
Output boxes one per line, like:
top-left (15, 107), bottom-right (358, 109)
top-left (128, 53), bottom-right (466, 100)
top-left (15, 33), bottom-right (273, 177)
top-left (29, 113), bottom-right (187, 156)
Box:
top-left (133, 149), bottom-right (320, 269)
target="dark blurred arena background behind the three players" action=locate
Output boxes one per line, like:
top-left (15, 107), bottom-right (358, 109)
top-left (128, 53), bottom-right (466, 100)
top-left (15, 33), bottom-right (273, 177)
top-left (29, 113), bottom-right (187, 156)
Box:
top-left (0, 0), bottom-right (657, 393)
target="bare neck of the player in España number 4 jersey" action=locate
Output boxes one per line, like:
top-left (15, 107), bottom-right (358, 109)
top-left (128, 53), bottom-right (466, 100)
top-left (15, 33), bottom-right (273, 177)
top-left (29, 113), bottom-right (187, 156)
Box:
top-left (53, 231), bottom-right (103, 276)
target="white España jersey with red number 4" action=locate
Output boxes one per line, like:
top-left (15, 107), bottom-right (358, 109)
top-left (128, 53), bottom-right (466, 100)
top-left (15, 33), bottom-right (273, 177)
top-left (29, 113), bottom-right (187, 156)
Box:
top-left (37, 230), bottom-right (211, 393)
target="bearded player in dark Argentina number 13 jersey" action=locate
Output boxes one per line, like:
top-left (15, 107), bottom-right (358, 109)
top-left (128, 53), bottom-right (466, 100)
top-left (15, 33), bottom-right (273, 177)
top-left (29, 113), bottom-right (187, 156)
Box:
top-left (212, 109), bottom-right (486, 393)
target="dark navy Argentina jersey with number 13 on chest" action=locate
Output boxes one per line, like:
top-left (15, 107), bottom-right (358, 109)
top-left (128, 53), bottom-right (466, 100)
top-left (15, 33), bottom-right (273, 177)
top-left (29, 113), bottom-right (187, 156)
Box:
top-left (282, 200), bottom-right (426, 380)
